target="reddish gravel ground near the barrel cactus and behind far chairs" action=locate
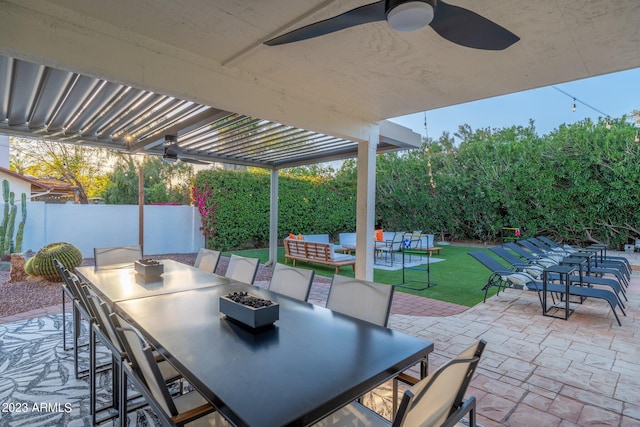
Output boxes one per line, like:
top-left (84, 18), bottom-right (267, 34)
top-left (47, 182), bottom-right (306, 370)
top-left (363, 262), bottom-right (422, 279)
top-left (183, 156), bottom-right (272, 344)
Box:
top-left (0, 254), bottom-right (271, 317)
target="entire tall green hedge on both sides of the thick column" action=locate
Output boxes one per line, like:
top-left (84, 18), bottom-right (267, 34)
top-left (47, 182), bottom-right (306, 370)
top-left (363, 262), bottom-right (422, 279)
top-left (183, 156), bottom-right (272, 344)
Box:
top-left (193, 117), bottom-right (640, 249)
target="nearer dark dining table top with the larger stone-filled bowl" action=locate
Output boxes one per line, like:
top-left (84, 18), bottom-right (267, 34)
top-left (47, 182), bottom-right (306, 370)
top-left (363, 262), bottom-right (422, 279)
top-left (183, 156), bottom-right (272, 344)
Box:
top-left (115, 283), bottom-right (433, 427)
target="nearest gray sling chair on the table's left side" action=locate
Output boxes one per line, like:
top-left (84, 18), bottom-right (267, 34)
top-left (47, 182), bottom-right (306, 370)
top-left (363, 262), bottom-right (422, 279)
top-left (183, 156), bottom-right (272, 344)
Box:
top-left (111, 313), bottom-right (230, 426)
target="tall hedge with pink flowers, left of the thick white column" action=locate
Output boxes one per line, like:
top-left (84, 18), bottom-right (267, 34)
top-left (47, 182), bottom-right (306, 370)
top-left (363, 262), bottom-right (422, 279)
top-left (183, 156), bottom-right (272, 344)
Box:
top-left (192, 170), bottom-right (356, 250)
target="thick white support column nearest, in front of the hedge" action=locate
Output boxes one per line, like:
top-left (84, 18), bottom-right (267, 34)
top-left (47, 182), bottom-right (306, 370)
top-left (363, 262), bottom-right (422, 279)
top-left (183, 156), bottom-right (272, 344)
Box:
top-left (355, 126), bottom-right (380, 280)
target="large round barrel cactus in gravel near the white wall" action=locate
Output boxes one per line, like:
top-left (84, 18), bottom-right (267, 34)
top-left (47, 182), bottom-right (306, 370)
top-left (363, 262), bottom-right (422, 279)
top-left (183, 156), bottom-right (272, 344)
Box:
top-left (24, 242), bottom-right (82, 280)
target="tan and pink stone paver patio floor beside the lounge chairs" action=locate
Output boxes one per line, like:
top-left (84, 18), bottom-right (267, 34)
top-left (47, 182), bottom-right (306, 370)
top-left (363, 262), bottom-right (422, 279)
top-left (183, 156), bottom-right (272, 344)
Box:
top-left (0, 256), bottom-right (640, 427)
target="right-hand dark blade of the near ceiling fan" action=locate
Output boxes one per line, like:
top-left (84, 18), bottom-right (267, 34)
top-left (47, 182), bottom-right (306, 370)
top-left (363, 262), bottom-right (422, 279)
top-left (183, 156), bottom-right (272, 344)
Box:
top-left (429, 0), bottom-right (520, 50)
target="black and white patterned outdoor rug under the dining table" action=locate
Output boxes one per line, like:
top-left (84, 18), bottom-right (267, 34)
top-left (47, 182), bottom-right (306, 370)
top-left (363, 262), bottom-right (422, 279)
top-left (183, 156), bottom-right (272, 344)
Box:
top-left (0, 314), bottom-right (404, 427)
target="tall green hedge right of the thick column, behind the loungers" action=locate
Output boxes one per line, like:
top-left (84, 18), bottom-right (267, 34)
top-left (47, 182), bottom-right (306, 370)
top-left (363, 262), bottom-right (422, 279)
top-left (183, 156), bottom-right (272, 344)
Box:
top-left (376, 117), bottom-right (640, 248)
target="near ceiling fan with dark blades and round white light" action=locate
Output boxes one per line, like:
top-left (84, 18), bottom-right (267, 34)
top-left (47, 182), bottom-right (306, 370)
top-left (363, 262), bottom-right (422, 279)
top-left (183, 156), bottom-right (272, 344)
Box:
top-left (264, 0), bottom-right (520, 50)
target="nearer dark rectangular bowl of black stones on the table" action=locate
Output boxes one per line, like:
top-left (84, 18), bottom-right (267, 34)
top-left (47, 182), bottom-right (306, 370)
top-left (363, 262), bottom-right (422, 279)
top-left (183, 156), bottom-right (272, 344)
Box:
top-left (220, 292), bottom-right (280, 329)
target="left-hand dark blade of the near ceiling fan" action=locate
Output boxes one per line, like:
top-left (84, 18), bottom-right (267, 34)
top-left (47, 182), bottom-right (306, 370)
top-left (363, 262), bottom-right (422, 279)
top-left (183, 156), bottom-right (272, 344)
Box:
top-left (264, 0), bottom-right (386, 46)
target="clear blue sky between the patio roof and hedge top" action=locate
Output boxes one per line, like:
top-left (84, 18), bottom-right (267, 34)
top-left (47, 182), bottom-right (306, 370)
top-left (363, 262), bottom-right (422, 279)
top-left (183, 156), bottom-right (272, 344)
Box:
top-left (390, 68), bottom-right (640, 139)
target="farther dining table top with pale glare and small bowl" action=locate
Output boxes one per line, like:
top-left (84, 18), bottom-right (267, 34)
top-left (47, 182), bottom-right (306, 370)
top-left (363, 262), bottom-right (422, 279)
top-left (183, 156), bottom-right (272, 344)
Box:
top-left (76, 259), bottom-right (231, 304)
